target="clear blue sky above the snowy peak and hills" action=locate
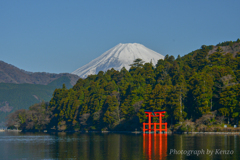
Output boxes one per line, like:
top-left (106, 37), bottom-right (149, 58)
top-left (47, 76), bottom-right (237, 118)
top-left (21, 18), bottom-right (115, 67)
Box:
top-left (0, 0), bottom-right (240, 73)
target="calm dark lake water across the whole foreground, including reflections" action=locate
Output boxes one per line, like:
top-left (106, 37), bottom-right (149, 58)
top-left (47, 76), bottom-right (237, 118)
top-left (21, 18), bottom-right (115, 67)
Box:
top-left (0, 132), bottom-right (240, 160)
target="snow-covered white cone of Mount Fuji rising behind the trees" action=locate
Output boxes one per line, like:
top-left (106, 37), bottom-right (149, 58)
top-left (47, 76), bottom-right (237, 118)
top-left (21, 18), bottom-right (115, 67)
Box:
top-left (72, 43), bottom-right (164, 78)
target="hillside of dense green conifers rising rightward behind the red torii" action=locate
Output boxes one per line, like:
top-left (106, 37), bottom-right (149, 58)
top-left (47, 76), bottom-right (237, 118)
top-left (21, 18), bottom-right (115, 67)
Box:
top-left (8, 39), bottom-right (240, 130)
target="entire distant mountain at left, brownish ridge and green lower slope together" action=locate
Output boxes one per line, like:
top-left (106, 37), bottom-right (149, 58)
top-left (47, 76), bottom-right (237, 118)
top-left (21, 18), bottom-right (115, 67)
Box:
top-left (0, 61), bottom-right (79, 126)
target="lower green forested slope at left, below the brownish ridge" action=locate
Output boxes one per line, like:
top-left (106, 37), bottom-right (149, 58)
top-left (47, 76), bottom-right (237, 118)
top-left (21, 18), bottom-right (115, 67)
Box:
top-left (0, 76), bottom-right (72, 126)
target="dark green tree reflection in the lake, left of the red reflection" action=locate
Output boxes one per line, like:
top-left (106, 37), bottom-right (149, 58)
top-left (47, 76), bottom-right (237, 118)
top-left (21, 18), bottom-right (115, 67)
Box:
top-left (54, 133), bottom-right (143, 160)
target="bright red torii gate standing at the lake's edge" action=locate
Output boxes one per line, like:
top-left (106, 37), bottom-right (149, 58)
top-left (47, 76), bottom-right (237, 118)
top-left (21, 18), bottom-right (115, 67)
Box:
top-left (143, 110), bottom-right (167, 133)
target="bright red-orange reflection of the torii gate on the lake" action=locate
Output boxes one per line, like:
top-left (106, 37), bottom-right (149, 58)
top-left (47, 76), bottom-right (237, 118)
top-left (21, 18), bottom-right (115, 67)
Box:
top-left (143, 134), bottom-right (167, 160)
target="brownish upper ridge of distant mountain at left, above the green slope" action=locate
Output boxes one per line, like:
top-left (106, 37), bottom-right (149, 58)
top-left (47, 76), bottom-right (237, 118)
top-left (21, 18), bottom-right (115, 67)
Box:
top-left (0, 61), bottom-right (79, 86)
